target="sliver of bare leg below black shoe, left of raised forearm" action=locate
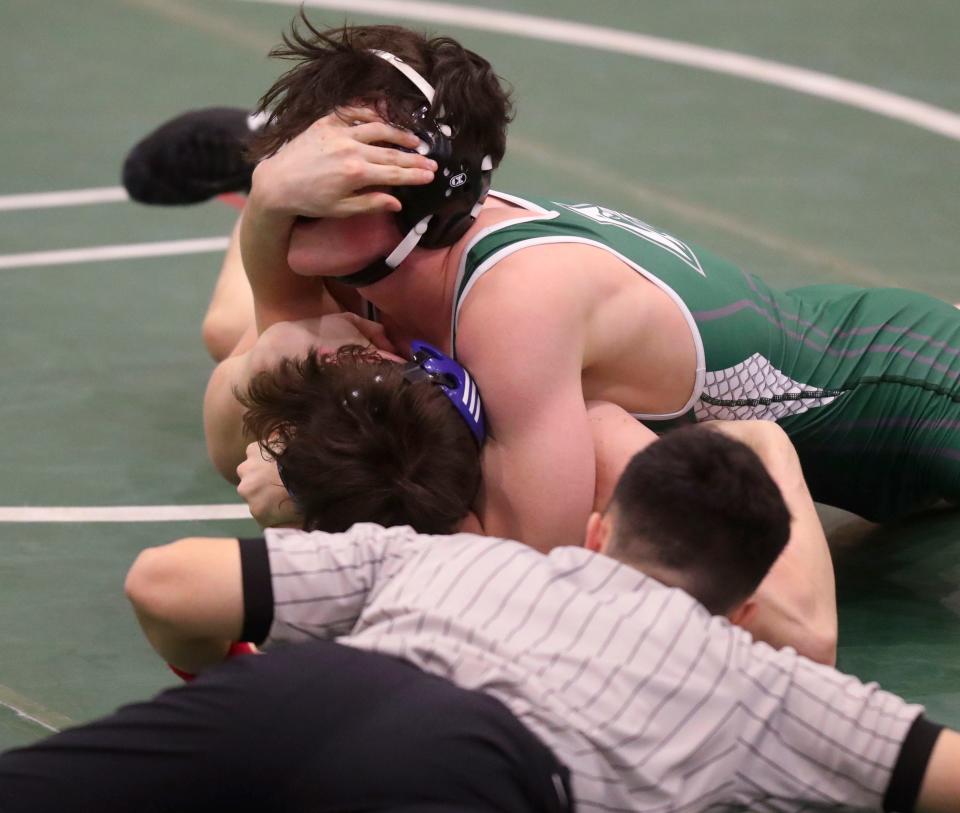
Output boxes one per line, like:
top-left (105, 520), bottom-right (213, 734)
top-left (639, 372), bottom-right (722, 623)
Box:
top-left (203, 215), bottom-right (254, 361)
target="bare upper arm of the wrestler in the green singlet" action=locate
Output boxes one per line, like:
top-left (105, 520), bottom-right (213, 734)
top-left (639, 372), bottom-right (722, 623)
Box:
top-left (458, 266), bottom-right (595, 550)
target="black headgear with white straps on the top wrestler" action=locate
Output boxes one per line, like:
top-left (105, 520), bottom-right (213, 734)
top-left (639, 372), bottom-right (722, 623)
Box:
top-left (337, 51), bottom-right (493, 288)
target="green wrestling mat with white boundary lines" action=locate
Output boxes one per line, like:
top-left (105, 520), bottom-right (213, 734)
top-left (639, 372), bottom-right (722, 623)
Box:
top-left (0, 0), bottom-right (960, 748)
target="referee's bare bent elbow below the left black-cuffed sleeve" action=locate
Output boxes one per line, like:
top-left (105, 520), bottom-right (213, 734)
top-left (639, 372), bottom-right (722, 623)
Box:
top-left (125, 537), bottom-right (244, 674)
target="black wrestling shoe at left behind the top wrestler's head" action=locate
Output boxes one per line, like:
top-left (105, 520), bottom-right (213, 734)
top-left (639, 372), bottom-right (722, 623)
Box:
top-left (123, 107), bottom-right (257, 206)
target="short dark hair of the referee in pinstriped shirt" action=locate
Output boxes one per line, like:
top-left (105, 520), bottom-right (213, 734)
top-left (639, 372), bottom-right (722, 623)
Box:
top-left (607, 426), bottom-right (790, 615)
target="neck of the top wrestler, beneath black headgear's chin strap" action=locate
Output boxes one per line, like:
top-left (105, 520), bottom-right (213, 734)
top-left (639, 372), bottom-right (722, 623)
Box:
top-left (363, 196), bottom-right (524, 352)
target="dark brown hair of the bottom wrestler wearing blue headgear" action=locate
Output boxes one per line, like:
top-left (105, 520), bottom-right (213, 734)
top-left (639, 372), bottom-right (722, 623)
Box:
top-left (238, 345), bottom-right (480, 534)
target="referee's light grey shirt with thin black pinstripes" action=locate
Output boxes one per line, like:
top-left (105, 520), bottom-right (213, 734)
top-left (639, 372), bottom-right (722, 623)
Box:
top-left (258, 524), bottom-right (922, 813)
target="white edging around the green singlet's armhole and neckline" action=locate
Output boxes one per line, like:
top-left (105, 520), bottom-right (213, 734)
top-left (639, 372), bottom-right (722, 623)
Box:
top-left (450, 192), bottom-right (707, 421)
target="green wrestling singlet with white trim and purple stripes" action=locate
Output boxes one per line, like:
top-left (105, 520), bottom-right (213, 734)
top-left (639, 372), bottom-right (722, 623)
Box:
top-left (453, 193), bottom-right (960, 520)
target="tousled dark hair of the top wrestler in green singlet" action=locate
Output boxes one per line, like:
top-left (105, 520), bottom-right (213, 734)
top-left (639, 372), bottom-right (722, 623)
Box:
top-left (250, 14), bottom-right (513, 165)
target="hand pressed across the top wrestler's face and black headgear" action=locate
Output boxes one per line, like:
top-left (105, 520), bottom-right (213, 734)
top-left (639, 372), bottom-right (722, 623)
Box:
top-left (251, 107), bottom-right (437, 217)
